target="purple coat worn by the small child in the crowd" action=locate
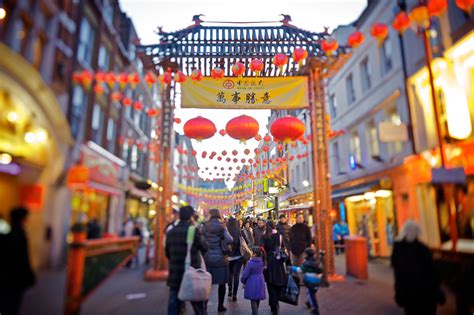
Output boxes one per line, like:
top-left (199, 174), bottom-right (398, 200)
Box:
top-left (241, 257), bottom-right (267, 301)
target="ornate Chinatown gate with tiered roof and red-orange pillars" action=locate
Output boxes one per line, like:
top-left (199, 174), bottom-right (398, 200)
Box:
top-left (139, 16), bottom-right (348, 279)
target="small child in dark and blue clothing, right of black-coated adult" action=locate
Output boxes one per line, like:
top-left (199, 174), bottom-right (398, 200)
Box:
top-left (291, 247), bottom-right (323, 314)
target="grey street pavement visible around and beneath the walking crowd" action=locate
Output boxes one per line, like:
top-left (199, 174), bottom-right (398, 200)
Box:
top-left (21, 255), bottom-right (454, 315)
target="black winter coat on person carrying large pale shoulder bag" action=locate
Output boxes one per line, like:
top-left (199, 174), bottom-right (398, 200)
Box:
top-left (165, 220), bottom-right (207, 289)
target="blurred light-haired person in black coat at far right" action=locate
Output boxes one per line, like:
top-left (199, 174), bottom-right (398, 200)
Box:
top-left (391, 220), bottom-right (445, 315)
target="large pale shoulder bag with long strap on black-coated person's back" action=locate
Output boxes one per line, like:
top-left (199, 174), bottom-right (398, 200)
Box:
top-left (178, 225), bottom-right (212, 302)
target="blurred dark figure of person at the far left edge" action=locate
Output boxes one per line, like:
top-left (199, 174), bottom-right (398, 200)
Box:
top-left (0, 207), bottom-right (36, 315)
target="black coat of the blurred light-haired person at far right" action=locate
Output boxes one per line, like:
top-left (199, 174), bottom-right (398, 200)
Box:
top-left (391, 241), bottom-right (440, 307)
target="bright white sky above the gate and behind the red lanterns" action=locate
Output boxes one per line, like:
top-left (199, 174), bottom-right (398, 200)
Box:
top-left (120, 0), bottom-right (367, 187)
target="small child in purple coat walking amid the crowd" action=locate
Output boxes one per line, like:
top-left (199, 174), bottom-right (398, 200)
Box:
top-left (241, 246), bottom-right (267, 315)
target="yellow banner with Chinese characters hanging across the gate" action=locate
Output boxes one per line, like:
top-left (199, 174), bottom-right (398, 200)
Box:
top-left (181, 76), bottom-right (308, 109)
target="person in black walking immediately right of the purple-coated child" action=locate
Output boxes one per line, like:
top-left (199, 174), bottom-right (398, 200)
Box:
top-left (261, 220), bottom-right (287, 315)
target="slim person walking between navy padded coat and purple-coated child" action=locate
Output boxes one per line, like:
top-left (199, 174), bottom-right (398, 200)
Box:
top-left (227, 218), bottom-right (244, 302)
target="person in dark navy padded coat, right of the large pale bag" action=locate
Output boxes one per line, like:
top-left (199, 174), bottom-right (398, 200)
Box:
top-left (202, 209), bottom-right (234, 312)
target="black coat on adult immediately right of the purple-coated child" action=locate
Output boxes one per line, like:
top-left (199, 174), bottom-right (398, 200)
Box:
top-left (262, 232), bottom-right (286, 286)
